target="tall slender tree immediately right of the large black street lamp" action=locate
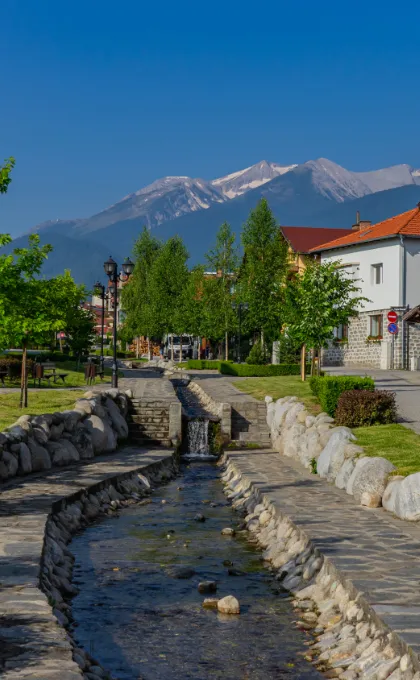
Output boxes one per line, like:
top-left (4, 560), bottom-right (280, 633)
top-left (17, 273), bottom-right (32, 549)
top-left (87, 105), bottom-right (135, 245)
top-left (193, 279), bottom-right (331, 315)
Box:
top-left (121, 227), bottom-right (163, 356)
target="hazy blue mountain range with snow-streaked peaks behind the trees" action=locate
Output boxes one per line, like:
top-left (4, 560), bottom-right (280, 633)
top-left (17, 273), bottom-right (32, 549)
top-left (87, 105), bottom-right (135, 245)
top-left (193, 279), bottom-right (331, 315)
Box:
top-left (7, 158), bottom-right (420, 286)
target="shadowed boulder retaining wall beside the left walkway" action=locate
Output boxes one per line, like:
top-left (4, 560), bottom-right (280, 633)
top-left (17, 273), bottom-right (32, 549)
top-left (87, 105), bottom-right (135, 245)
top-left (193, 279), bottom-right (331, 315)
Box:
top-left (0, 389), bottom-right (132, 482)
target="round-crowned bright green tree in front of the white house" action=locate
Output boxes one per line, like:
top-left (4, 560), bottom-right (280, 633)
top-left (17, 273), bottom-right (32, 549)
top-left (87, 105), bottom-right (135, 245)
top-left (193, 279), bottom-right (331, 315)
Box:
top-left (286, 261), bottom-right (368, 379)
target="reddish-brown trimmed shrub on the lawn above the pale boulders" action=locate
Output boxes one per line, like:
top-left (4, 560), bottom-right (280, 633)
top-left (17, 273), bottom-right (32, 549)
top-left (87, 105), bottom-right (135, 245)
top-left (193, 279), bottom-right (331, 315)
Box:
top-left (335, 390), bottom-right (397, 427)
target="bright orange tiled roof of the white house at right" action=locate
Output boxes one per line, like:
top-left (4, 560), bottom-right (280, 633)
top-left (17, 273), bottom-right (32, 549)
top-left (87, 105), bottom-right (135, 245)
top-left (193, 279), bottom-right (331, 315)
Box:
top-left (311, 206), bottom-right (420, 253)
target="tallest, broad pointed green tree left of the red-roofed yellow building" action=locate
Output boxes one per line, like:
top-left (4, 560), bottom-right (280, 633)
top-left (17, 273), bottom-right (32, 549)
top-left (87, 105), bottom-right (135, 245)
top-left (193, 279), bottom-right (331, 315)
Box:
top-left (238, 198), bottom-right (289, 346)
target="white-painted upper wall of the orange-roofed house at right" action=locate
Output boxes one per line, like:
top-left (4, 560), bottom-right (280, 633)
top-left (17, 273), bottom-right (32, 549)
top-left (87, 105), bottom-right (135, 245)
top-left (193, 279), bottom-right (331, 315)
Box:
top-left (321, 239), bottom-right (402, 312)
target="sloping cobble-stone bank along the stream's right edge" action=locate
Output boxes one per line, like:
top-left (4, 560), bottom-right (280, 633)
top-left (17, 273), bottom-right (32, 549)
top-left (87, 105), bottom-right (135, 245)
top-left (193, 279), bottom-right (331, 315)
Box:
top-left (222, 453), bottom-right (420, 680)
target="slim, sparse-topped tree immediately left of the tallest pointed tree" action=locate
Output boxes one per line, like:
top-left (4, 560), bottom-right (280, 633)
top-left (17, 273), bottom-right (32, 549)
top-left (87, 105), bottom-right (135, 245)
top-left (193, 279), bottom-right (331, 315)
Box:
top-left (204, 222), bottom-right (239, 360)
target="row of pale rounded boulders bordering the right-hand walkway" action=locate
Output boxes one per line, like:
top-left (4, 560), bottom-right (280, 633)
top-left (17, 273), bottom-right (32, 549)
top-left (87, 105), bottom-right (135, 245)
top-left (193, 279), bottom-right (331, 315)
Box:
top-left (266, 397), bottom-right (420, 521)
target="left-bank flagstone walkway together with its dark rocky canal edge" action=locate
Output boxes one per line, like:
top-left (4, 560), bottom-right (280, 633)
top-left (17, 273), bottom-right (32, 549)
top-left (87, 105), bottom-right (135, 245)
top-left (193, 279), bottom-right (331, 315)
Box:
top-left (0, 447), bottom-right (177, 680)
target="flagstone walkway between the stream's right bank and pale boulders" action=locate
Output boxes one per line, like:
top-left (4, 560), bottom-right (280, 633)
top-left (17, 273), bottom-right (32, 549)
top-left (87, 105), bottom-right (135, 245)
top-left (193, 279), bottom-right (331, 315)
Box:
top-left (228, 451), bottom-right (420, 654)
